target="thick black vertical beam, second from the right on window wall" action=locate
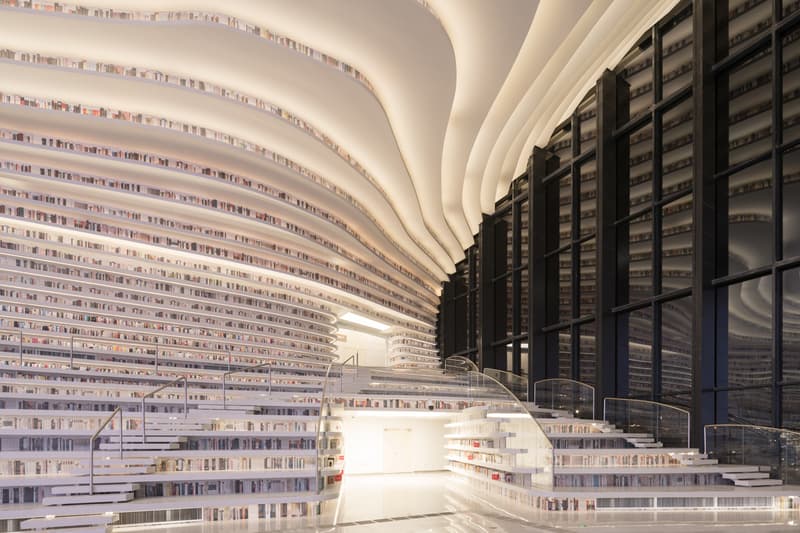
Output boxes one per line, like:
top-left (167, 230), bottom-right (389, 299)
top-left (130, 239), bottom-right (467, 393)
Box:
top-left (595, 70), bottom-right (629, 405)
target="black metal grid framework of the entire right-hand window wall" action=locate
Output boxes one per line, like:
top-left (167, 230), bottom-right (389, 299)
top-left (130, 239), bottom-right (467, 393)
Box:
top-left (440, 0), bottom-right (800, 445)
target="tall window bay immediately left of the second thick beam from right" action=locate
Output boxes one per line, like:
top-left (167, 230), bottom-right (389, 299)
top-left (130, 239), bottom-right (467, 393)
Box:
top-left (542, 92), bottom-right (597, 383)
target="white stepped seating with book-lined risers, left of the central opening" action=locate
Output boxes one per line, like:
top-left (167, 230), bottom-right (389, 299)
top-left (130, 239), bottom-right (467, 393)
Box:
top-left (0, 344), bottom-right (341, 533)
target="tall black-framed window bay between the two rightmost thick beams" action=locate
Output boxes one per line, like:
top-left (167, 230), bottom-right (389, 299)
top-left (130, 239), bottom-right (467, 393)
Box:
top-left (613, 5), bottom-right (693, 405)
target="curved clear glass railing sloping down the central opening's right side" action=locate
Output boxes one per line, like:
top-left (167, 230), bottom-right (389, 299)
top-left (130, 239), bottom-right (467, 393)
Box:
top-left (469, 372), bottom-right (554, 489)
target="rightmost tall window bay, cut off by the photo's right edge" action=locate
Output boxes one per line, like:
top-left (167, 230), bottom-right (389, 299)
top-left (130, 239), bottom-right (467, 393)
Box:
top-left (713, 1), bottom-right (800, 428)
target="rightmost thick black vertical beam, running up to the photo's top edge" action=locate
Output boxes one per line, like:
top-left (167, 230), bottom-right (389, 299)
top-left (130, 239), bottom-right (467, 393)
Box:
top-left (691, 1), bottom-right (727, 446)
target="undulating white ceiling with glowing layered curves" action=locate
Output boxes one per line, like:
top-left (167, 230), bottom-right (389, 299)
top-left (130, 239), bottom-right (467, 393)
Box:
top-left (0, 0), bottom-right (676, 279)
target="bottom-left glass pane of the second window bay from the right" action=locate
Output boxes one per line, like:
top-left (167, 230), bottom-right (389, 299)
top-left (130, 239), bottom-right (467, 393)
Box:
top-left (627, 307), bottom-right (653, 397)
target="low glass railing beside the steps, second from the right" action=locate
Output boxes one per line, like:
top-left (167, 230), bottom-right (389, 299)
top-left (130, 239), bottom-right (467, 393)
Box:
top-left (603, 398), bottom-right (691, 448)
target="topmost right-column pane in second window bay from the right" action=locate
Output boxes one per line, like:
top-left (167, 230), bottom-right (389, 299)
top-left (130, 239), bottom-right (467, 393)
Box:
top-left (661, 4), bottom-right (693, 98)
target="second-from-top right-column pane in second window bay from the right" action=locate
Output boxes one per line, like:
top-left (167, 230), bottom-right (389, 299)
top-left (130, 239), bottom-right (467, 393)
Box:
top-left (661, 97), bottom-right (694, 196)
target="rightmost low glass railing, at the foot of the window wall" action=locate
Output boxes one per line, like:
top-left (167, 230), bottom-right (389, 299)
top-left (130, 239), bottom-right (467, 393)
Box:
top-left (703, 424), bottom-right (800, 485)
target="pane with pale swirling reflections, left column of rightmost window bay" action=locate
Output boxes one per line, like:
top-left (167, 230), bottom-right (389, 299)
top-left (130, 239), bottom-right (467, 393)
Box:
top-left (721, 276), bottom-right (772, 387)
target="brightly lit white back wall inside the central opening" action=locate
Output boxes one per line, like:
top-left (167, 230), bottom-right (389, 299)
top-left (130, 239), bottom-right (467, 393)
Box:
top-left (342, 411), bottom-right (450, 474)
